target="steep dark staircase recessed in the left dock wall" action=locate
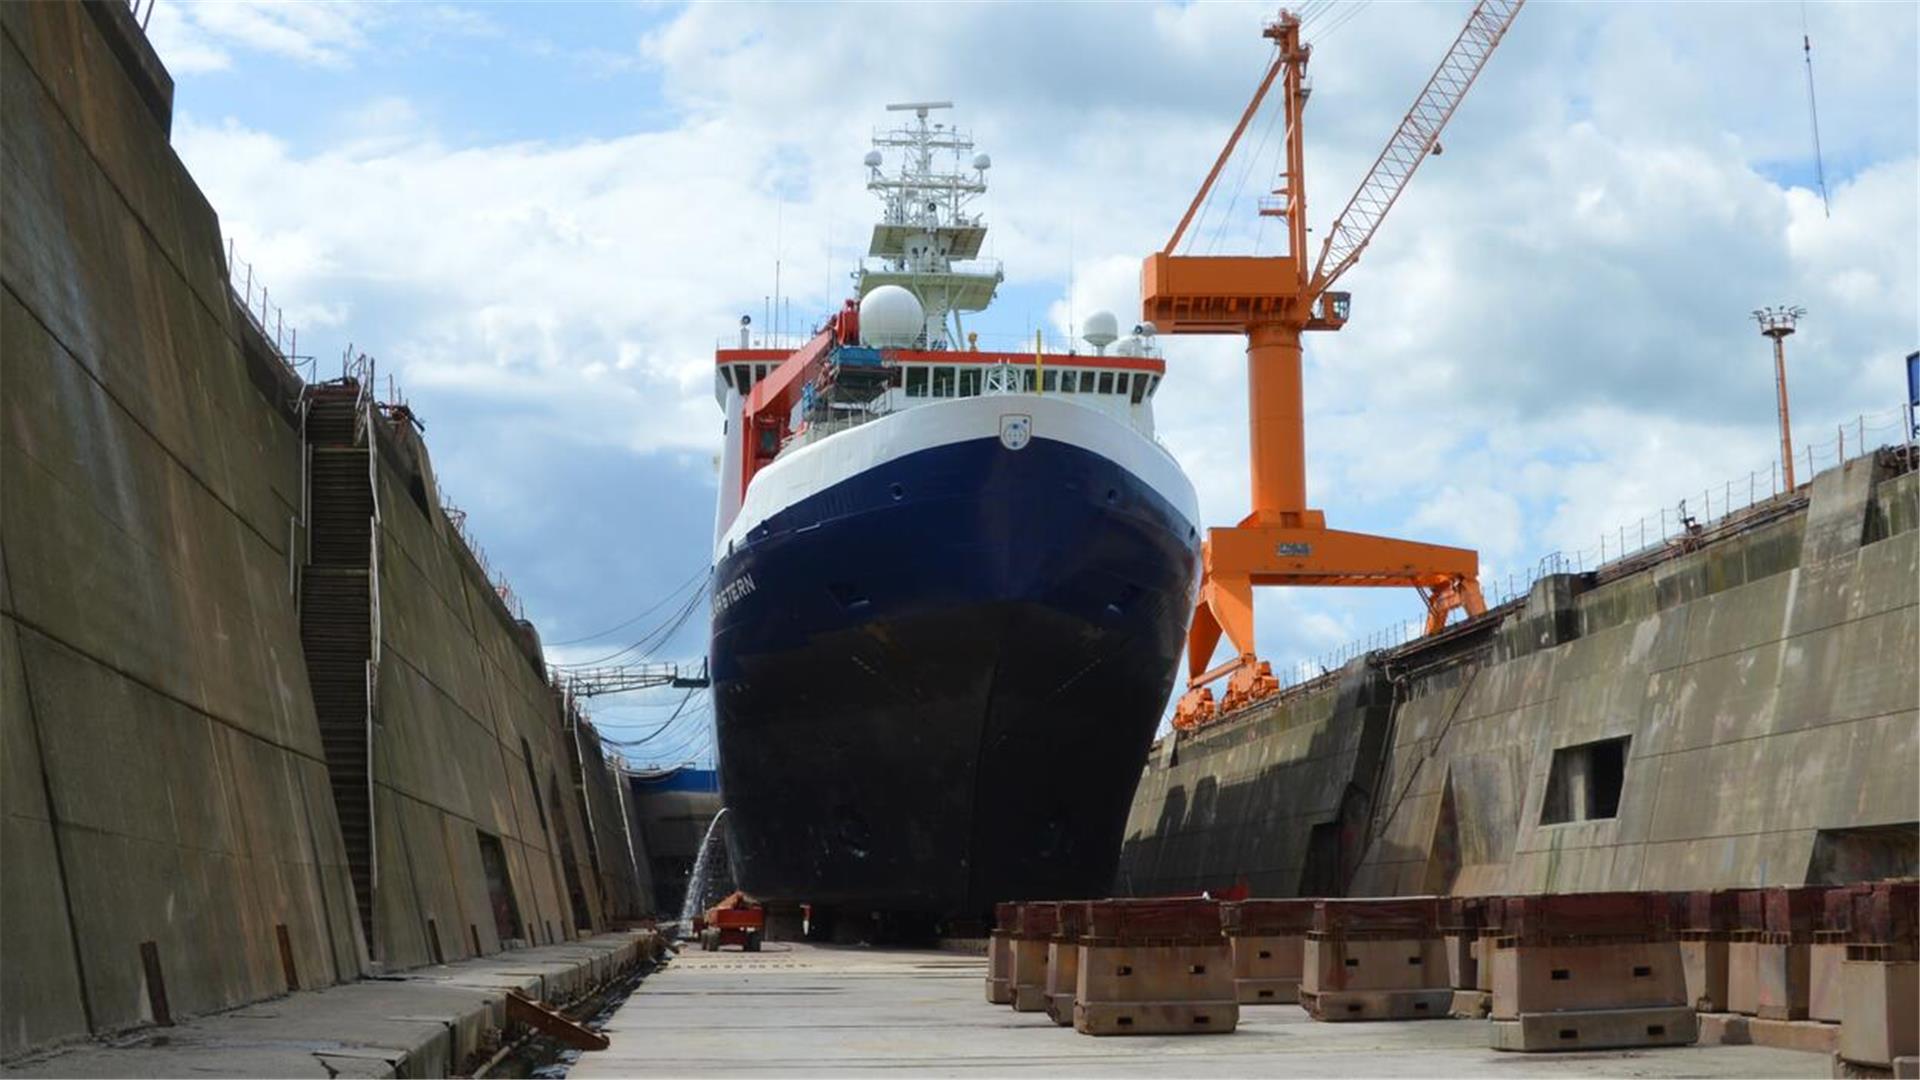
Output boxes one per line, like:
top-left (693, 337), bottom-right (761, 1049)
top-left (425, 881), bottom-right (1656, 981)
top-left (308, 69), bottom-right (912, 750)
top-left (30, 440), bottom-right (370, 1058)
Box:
top-left (300, 380), bottom-right (380, 957)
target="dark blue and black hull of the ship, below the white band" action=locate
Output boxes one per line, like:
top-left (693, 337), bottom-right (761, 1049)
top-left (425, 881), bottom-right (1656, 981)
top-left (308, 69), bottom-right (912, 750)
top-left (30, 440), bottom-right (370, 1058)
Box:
top-left (708, 430), bottom-right (1198, 917)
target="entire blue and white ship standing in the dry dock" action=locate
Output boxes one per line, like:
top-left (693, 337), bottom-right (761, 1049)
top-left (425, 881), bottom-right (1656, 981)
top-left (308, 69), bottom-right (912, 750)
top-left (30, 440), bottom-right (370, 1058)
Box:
top-left (710, 102), bottom-right (1200, 917)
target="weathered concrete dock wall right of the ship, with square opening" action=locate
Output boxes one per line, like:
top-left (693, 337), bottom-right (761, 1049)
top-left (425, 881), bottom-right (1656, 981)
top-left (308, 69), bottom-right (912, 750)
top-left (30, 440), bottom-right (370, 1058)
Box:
top-left (1117, 454), bottom-right (1920, 896)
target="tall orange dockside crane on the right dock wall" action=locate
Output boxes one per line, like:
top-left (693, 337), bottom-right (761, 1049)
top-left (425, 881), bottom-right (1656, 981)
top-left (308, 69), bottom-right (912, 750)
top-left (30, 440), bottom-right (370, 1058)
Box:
top-left (1140, 0), bottom-right (1524, 728)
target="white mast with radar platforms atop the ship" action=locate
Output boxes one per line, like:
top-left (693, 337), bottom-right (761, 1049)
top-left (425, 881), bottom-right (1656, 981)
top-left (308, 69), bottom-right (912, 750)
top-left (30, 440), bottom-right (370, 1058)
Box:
top-left (856, 102), bottom-right (1004, 350)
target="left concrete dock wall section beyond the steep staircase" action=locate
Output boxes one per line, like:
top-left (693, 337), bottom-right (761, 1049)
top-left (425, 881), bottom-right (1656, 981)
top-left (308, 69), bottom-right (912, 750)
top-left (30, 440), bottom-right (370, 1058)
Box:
top-left (372, 421), bottom-right (605, 967)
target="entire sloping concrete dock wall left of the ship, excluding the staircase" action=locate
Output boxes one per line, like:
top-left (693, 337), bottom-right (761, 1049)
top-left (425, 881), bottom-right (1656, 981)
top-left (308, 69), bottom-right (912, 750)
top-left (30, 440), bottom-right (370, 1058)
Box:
top-left (0, 0), bottom-right (647, 1059)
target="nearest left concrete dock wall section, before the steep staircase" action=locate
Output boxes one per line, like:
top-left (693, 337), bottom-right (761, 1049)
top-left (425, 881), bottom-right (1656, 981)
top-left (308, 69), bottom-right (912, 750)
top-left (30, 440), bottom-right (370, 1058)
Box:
top-left (0, 4), bottom-right (361, 1055)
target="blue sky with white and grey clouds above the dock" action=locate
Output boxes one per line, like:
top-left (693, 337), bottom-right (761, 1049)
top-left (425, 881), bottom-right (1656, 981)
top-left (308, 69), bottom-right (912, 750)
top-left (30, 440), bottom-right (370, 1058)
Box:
top-left (150, 0), bottom-right (1920, 759)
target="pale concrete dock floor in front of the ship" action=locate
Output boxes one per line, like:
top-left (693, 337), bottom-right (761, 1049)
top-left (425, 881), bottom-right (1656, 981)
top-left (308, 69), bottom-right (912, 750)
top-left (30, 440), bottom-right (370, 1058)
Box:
top-left (568, 944), bottom-right (1830, 1078)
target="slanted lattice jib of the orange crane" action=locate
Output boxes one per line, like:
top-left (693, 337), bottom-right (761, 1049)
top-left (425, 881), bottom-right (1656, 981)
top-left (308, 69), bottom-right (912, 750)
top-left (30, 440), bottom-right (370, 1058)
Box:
top-left (1309, 0), bottom-right (1526, 294)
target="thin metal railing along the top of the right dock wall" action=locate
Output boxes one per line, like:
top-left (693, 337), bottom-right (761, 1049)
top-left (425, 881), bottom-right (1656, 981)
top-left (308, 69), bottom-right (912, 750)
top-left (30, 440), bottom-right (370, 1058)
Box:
top-left (1275, 407), bottom-right (1914, 688)
